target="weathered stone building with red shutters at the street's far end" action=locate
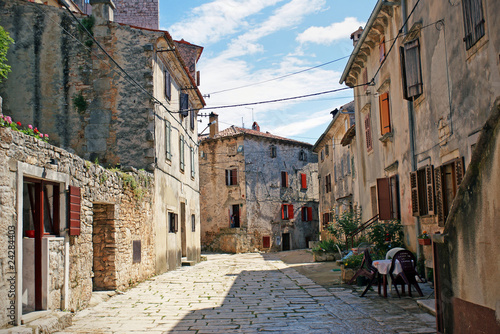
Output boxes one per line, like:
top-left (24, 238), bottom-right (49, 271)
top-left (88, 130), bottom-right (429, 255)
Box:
top-left (200, 114), bottom-right (319, 253)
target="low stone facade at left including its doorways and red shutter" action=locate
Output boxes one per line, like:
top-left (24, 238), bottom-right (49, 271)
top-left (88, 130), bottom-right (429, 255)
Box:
top-left (0, 127), bottom-right (155, 327)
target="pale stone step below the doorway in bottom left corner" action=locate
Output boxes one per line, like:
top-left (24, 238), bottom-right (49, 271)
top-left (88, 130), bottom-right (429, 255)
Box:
top-left (0, 311), bottom-right (73, 334)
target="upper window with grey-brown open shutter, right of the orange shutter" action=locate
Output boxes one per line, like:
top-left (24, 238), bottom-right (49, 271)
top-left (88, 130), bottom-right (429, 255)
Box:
top-left (400, 39), bottom-right (423, 101)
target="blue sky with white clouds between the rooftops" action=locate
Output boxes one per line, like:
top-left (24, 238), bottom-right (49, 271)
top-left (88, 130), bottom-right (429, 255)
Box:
top-left (160, 0), bottom-right (376, 144)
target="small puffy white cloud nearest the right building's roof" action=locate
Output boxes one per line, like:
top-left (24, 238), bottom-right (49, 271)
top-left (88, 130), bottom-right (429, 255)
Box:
top-left (297, 17), bottom-right (365, 45)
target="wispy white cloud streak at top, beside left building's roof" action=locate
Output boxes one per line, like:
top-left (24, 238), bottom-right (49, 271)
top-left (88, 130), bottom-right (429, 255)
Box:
top-left (168, 0), bottom-right (283, 46)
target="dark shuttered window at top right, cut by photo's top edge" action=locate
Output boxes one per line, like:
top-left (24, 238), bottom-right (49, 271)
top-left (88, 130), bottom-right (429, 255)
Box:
top-left (462, 0), bottom-right (484, 50)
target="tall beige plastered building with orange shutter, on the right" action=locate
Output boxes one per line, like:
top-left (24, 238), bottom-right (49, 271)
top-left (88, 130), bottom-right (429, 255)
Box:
top-left (341, 0), bottom-right (500, 332)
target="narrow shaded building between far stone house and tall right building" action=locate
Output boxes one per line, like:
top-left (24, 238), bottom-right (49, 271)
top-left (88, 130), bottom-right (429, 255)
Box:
top-left (313, 101), bottom-right (357, 239)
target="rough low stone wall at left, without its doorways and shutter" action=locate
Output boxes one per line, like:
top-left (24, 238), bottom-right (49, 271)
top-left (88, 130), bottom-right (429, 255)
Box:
top-left (0, 128), bottom-right (155, 326)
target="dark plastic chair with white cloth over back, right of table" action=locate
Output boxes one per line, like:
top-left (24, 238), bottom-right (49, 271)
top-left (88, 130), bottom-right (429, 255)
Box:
top-left (389, 250), bottom-right (423, 298)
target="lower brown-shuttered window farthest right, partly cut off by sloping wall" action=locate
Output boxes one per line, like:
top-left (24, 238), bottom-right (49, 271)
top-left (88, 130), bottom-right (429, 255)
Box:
top-left (434, 157), bottom-right (465, 226)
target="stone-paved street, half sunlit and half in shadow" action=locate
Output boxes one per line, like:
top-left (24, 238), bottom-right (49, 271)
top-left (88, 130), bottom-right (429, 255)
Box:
top-left (56, 254), bottom-right (435, 334)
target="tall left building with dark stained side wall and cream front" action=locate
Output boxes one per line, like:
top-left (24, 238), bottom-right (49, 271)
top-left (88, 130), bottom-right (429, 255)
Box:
top-left (0, 0), bottom-right (204, 324)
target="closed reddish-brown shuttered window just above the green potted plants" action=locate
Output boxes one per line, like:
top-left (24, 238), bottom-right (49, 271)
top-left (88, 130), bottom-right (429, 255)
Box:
top-left (377, 175), bottom-right (400, 220)
